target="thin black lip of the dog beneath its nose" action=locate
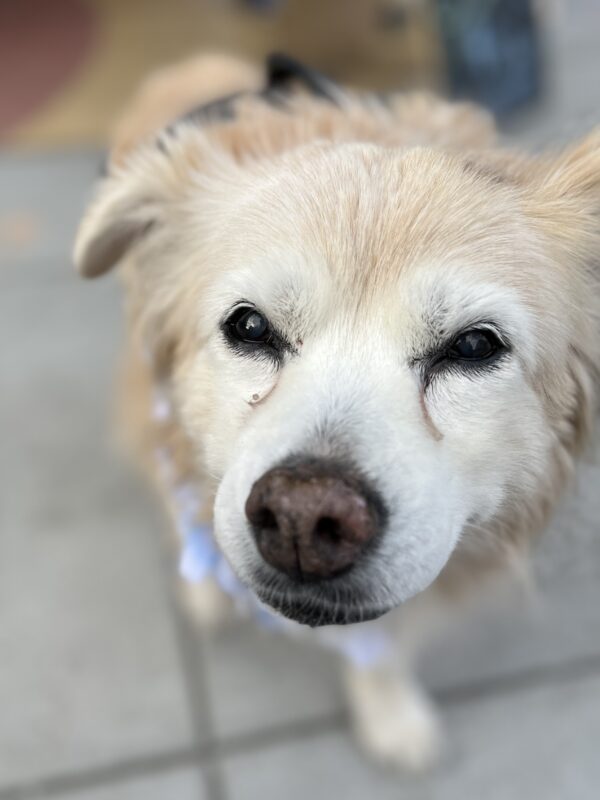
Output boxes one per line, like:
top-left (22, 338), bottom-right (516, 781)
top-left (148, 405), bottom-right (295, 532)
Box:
top-left (254, 588), bottom-right (391, 628)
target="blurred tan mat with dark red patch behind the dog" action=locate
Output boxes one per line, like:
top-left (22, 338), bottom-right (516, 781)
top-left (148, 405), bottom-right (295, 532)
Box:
top-left (0, 0), bottom-right (439, 148)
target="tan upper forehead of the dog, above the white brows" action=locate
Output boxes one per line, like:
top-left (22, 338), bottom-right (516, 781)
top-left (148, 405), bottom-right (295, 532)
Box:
top-left (223, 145), bottom-right (524, 293)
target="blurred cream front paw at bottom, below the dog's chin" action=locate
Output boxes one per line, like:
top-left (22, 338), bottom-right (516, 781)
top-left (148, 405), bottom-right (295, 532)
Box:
top-left (350, 674), bottom-right (442, 772)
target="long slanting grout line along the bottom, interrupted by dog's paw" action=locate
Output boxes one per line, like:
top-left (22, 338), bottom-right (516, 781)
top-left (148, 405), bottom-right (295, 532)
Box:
top-left (0, 653), bottom-right (600, 800)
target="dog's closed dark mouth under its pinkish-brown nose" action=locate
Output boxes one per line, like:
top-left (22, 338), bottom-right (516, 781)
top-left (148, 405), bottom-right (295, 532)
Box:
top-left (253, 581), bottom-right (390, 628)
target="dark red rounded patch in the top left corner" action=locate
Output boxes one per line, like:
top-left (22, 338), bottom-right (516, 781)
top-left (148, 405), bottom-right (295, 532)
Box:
top-left (0, 0), bottom-right (96, 135)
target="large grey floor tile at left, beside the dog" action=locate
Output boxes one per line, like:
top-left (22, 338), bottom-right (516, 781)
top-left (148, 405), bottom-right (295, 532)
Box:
top-left (0, 281), bottom-right (192, 786)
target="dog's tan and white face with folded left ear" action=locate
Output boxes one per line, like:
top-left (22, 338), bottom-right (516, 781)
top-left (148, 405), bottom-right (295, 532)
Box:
top-left (78, 125), bottom-right (596, 624)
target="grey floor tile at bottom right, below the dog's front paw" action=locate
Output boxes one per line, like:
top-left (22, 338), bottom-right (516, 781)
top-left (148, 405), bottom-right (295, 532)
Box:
top-left (225, 677), bottom-right (600, 800)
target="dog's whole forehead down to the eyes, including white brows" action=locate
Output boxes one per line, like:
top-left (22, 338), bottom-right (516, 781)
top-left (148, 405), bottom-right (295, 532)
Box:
top-left (202, 145), bottom-right (560, 354)
